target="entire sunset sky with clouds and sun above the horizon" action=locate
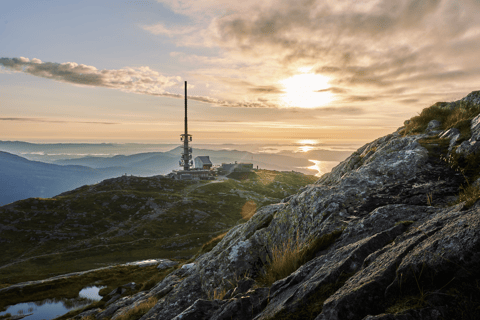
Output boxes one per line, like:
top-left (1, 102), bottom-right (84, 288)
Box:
top-left (0, 0), bottom-right (480, 143)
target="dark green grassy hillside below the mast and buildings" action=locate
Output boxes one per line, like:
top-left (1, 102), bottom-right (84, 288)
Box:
top-left (0, 170), bottom-right (316, 287)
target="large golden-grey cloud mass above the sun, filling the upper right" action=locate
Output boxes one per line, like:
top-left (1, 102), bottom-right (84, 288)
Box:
top-left (155, 0), bottom-right (480, 104)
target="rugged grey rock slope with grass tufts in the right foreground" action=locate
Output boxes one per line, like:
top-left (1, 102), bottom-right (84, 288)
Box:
top-left (86, 93), bottom-right (480, 320)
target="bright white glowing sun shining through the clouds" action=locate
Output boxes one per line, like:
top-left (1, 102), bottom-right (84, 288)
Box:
top-left (280, 73), bottom-right (334, 109)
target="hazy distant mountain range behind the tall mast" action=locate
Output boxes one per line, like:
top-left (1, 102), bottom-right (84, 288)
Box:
top-left (0, 142), bottom-right (314, 205)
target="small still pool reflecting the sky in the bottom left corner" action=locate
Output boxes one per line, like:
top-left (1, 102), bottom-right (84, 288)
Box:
top-left (0, 286), bottom-right (104, 320)
